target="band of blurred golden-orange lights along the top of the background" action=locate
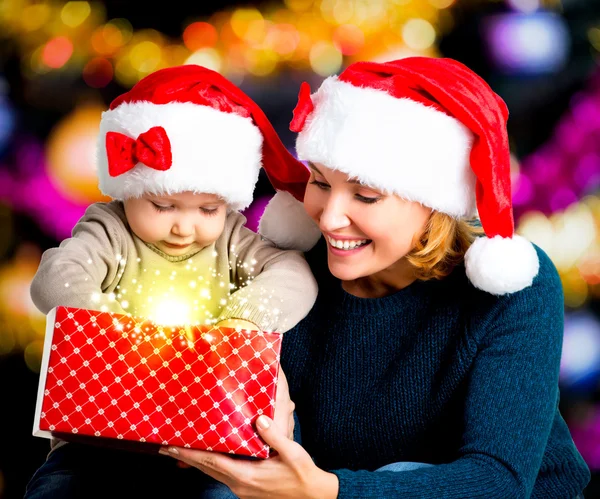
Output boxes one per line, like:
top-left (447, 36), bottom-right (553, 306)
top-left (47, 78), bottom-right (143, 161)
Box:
top-left (0, 0), bottom-right (453, 88)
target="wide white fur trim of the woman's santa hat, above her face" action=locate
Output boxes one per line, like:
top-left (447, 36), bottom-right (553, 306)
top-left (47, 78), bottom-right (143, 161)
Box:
top-left (296, 76), bottom-right (475, 217)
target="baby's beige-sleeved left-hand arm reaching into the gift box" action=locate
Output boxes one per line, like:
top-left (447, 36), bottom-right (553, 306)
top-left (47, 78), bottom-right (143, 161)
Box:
top-left (31, 203), bottom-right (125, 314)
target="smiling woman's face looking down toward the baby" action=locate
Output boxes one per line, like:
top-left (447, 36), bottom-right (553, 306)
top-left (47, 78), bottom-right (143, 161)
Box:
top-left (304, 163), bottom-right (431, 281)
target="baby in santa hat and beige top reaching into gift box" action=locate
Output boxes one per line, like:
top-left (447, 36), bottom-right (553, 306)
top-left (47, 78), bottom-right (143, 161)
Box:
top-left (31, 65), bottom-right (317, 332)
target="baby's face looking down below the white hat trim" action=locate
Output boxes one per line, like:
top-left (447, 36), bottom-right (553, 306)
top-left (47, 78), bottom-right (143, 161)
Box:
top-left (123, 192), bottom-right (227, 256)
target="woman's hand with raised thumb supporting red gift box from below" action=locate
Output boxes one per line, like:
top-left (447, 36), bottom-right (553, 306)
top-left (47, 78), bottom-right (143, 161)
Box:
top-left (160, 416), bottom-right (339, 499)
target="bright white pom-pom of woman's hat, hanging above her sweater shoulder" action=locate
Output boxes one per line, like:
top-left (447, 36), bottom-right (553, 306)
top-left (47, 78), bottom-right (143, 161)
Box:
top-left (465, 234), bottom-right (540, 295)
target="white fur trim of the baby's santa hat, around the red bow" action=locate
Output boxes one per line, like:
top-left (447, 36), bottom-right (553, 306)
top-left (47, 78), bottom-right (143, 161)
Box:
top-left (97, 102), bottom-right (263, 210)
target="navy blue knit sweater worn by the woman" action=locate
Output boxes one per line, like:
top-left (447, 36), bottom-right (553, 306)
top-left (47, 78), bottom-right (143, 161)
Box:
top-left (282, 241), bottom-right (590, 499)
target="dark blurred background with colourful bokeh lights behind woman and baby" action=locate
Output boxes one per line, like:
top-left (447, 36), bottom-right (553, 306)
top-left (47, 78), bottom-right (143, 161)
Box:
top-left (0, 0), bottom-right (600, 498)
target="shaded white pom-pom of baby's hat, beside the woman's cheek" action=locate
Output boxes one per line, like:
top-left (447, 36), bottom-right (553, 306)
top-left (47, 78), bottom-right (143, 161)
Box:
top-left (258, 191), bottom-right (321, 251)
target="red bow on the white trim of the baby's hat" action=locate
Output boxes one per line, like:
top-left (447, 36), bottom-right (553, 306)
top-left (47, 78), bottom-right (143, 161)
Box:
top-left (106, 126), bottom-right (173, 177)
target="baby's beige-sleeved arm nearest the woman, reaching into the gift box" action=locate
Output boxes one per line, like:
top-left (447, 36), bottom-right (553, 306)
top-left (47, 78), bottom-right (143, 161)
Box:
top-left (219, 214), bottom-right (317, 332)
